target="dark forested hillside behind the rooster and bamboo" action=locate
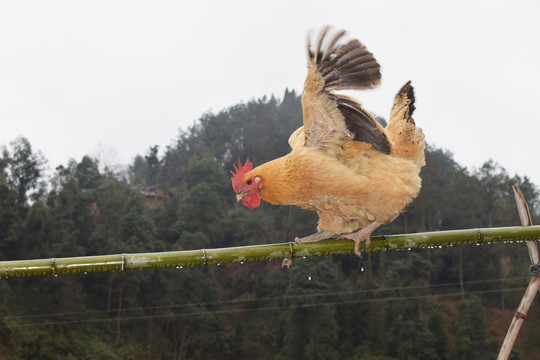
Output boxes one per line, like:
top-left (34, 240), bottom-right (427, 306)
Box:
top-left (0, 91), bottom-right (540, 360)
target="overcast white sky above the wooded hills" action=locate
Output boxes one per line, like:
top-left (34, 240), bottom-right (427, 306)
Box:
top-left (0, 0), bottom-right (540, 184)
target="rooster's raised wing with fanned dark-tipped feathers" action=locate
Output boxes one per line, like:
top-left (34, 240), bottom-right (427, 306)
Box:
top-left (298, 27), bottom-right (391, 154)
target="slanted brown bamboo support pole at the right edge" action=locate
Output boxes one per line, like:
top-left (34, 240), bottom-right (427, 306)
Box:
top-left (497, 186), bottom-right (540, 360)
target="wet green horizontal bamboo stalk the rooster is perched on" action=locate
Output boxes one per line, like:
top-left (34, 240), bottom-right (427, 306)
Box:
top-left (0, 226), bottom-right (540, 278)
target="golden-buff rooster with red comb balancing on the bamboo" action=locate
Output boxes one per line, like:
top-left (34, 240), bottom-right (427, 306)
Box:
top-left (231, 27), bottom-right (425, 256)
